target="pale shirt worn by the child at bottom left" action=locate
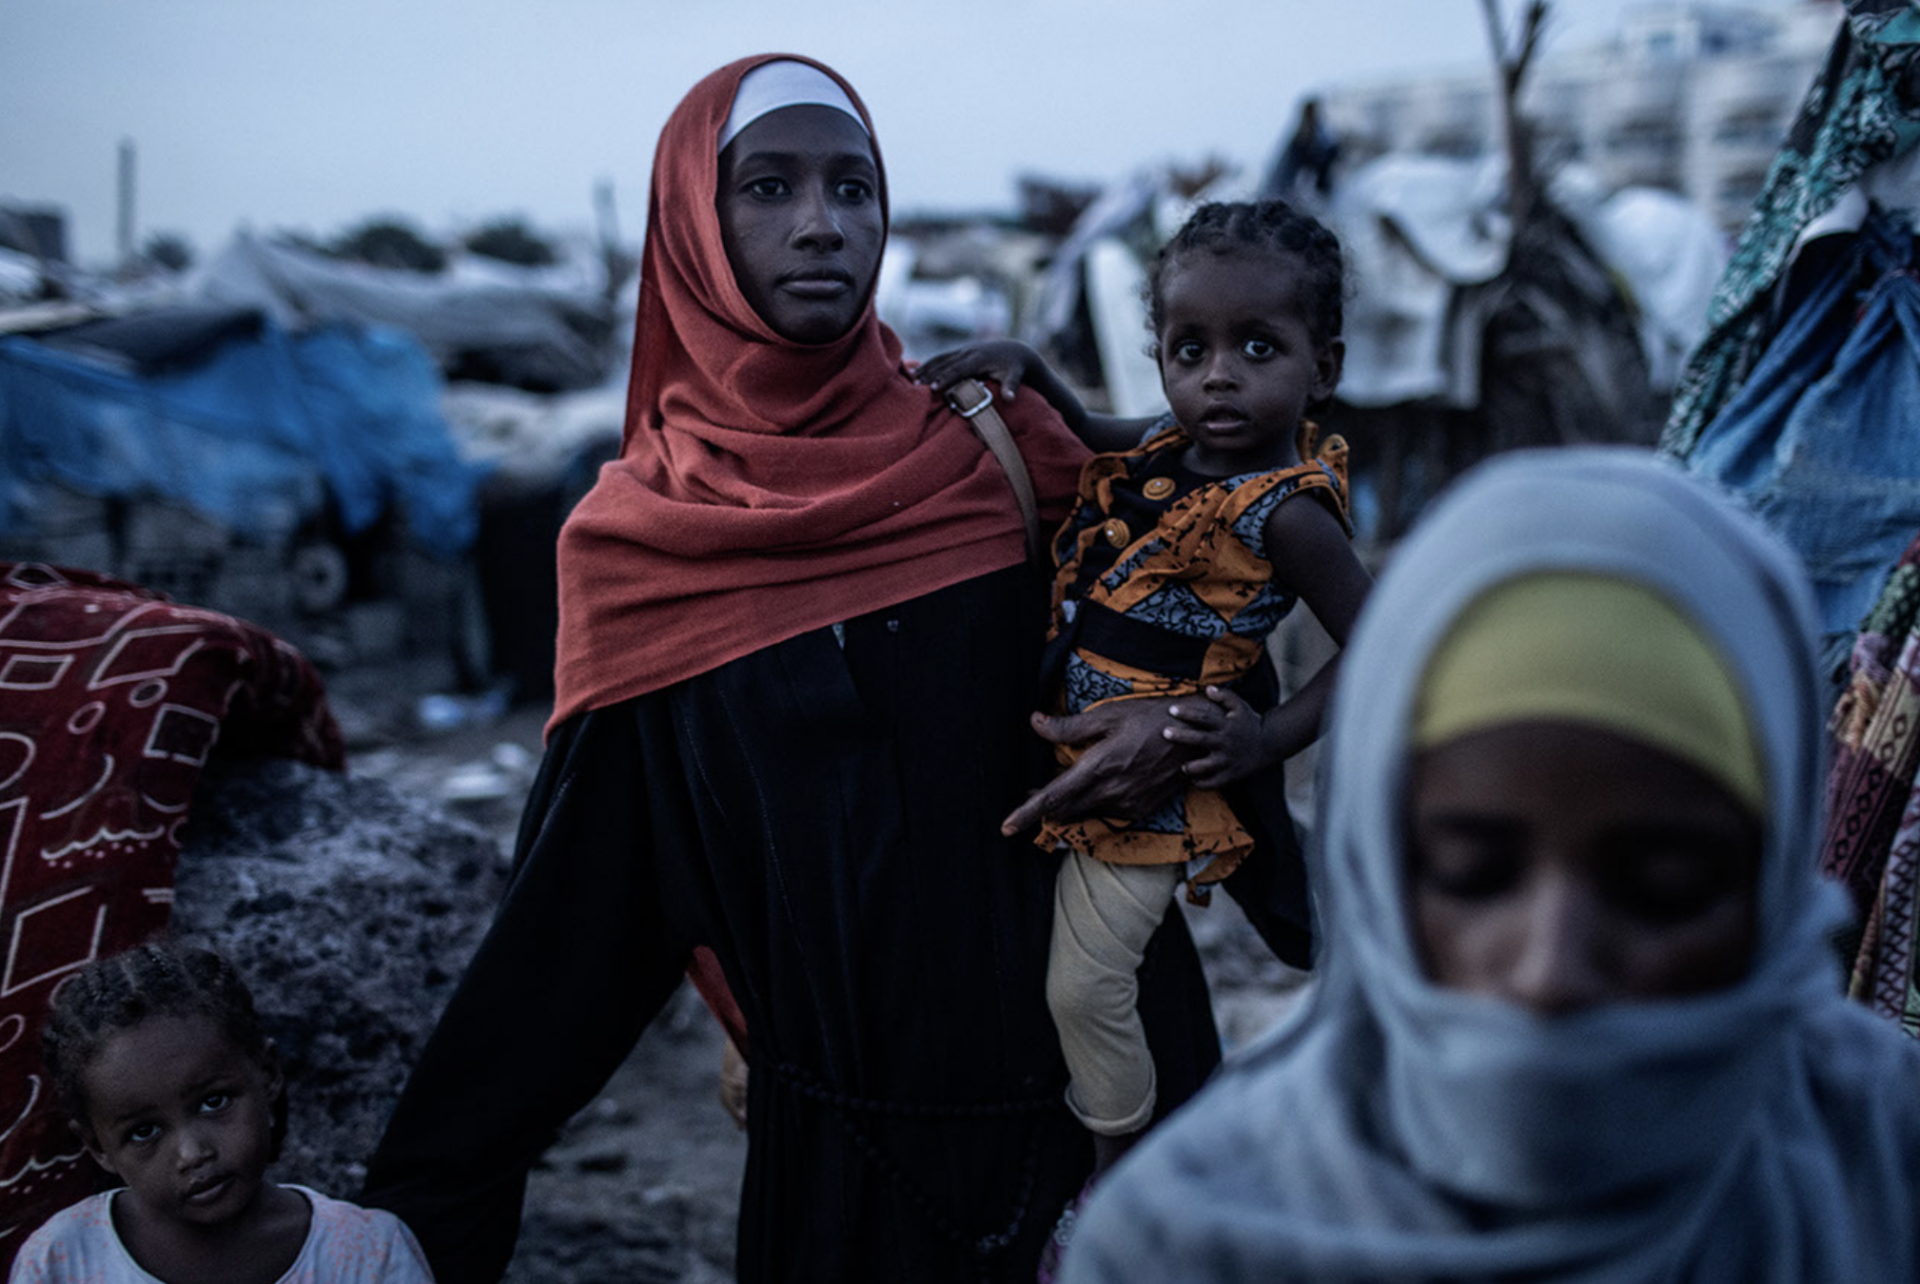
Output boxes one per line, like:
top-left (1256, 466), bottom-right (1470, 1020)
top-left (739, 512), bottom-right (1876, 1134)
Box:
top-left (10, 1186), bottom-right (434, 1284)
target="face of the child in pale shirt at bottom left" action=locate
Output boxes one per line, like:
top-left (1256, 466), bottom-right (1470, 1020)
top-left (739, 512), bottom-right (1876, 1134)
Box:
top-left (79, 1015), bottom-right (282, 1226)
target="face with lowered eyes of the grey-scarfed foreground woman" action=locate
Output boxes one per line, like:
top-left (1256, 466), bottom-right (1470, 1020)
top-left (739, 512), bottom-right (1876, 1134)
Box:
top-left (1407, 722), bottom-right (1761, 1015)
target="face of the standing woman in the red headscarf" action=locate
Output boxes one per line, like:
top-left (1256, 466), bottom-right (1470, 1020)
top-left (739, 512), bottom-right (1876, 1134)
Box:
top-left (714, 106), bottom-right (887, 344)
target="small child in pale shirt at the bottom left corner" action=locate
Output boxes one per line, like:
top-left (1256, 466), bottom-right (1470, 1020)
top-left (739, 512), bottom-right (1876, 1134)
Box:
top-left (8, 944), bottom-right (432, 1284)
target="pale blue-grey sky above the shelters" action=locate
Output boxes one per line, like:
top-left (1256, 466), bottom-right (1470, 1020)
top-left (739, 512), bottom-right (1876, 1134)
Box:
top-left (0, 0), bottom-right (1791, 261)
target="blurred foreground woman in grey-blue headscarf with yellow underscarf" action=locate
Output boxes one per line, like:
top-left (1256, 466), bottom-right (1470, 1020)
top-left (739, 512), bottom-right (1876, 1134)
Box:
top-left (1064, 449), bottom-right (1920, 1284)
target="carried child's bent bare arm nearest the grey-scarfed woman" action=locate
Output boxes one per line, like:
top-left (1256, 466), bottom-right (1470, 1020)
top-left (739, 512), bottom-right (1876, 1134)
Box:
top-left (1164, 495), bottom-right (1373, 789)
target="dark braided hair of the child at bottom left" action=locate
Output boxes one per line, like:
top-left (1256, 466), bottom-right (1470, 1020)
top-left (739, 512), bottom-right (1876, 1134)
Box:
top-left (40, 942), bottom-right (286, 1155)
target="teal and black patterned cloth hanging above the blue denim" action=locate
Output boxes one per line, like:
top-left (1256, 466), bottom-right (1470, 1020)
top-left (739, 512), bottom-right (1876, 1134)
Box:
top-left (1661, 0), bottom-right (1920, 459)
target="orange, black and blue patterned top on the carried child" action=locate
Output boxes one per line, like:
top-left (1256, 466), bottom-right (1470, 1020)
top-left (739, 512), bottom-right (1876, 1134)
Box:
top-left (1035, 422), bottom-right (1352, 882)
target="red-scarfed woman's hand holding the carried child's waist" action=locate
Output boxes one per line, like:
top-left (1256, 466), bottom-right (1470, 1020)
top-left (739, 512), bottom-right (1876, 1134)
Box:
top-left (1000, 697), bottom-right (1192, 837)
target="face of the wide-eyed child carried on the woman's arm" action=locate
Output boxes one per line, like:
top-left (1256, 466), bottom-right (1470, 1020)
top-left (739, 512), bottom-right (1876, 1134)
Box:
top-left (1158, 250), bottom-right (1344, 476)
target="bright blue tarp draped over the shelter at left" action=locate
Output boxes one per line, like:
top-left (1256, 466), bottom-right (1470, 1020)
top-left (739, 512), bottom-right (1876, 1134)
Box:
top-left (0, 322), bottom-right (484, 555)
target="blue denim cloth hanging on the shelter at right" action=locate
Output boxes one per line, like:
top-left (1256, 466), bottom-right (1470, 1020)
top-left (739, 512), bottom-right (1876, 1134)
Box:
top-left (1686, 213), bottom-right (1920, 635)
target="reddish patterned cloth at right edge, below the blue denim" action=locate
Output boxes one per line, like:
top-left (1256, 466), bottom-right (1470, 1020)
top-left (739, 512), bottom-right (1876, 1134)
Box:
top-left (1820, 539), bottom-right (1920, 1036)
